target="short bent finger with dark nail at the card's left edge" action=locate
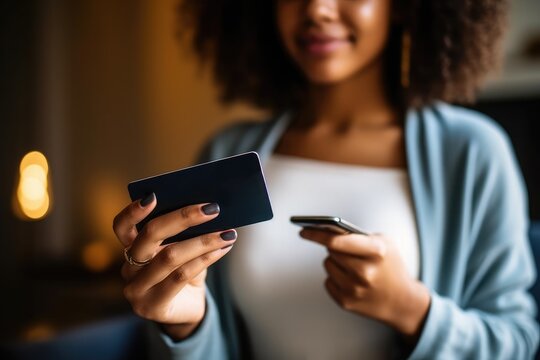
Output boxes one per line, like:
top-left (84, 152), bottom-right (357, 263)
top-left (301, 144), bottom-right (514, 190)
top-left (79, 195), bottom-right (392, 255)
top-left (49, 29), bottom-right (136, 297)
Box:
top-left (113, 193), bottom-right (156, 247)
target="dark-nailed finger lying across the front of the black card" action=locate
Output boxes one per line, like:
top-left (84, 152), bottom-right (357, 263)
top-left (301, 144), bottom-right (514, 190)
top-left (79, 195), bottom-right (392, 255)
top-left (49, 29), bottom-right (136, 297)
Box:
top-left (129, 204), bottom-right (219, 268)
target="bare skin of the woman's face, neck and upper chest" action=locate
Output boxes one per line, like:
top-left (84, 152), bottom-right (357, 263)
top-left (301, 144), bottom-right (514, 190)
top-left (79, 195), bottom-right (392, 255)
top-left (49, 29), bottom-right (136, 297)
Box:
top-left (276, 0), bottom-right (405, 167)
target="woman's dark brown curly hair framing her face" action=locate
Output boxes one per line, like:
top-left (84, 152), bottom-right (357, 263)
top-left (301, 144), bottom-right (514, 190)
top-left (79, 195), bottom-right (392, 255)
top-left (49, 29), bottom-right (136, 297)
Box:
top-left (178, 0), bottom-right (508, 112)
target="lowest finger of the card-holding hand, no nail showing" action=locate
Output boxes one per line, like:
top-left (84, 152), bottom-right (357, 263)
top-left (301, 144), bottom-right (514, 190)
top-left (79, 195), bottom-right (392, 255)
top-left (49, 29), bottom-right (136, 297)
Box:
top-left (149, 245), bottom-right (233, 303)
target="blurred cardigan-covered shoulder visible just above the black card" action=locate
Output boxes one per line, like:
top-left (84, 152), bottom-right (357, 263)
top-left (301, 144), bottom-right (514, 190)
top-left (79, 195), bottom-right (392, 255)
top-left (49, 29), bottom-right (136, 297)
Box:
top-left (198, 117), bottom-right (275, 162)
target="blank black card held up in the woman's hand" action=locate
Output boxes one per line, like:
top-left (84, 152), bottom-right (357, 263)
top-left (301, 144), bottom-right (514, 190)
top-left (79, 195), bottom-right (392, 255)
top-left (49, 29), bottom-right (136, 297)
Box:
top-left (128, 152), bottom-right (273, 244)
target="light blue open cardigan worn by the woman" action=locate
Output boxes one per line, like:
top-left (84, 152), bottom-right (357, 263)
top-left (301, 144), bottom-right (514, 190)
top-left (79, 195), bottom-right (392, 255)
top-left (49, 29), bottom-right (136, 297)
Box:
top-left (151, 103), bottom-right (539, 359)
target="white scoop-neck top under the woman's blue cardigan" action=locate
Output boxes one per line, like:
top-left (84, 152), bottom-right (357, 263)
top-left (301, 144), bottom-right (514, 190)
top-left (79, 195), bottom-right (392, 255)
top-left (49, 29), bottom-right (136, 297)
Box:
top-left (227, 155), bottom-right (419, 360)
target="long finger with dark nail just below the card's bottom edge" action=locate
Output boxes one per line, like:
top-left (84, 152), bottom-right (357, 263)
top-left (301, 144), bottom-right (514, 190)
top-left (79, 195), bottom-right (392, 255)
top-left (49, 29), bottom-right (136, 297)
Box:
top-left (129, 229), bottom-right (237, 292)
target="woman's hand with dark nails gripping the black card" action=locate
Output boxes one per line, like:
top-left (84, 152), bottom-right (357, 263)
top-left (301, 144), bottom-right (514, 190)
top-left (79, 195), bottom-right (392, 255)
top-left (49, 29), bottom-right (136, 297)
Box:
top-left (113, 194), bottom-right (236, 340)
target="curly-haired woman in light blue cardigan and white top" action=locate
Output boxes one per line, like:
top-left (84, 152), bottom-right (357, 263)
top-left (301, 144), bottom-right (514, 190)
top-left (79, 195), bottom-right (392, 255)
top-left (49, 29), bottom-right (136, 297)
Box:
top-left (114, 0), bottom-right (538, 359)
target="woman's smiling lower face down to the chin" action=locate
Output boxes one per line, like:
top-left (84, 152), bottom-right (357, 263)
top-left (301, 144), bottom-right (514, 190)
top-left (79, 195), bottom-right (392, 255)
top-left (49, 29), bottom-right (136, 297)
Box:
top-left (277, 0), bottom-right (390, 84)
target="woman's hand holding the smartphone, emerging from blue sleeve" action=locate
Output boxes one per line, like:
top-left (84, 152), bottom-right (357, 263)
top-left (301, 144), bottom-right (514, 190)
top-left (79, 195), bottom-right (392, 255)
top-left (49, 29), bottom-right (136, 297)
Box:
top-left (300, 229), bottom-right (431, 342)
